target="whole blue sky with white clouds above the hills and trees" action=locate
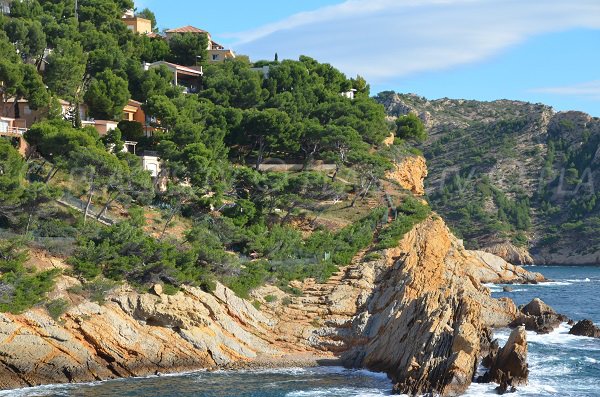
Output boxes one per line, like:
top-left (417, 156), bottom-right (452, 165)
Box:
top-left (136, 0), bottom-right (600, 117)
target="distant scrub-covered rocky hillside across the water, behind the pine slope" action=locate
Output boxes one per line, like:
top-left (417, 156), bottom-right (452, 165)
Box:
top-left (377, 92), bottom-right (600, 264)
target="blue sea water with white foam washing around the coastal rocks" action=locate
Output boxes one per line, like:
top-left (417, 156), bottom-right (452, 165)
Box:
top-left (0, 266), bottom-right (600, 397)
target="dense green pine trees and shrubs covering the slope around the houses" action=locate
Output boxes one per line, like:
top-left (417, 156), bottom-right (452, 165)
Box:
top-left (0, 0), bottom-right (429, 311)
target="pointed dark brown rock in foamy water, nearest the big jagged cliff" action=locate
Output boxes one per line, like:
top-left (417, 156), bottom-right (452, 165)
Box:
top-left (477, 327), bottom-right (529, 394)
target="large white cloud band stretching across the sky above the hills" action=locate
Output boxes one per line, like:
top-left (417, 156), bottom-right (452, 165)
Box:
top-left (230, 0), bottom-right (600, 82)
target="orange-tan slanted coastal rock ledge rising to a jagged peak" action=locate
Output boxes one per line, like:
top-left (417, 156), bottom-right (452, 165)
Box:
top-left (0, 215), bottom-right (541, 396)
